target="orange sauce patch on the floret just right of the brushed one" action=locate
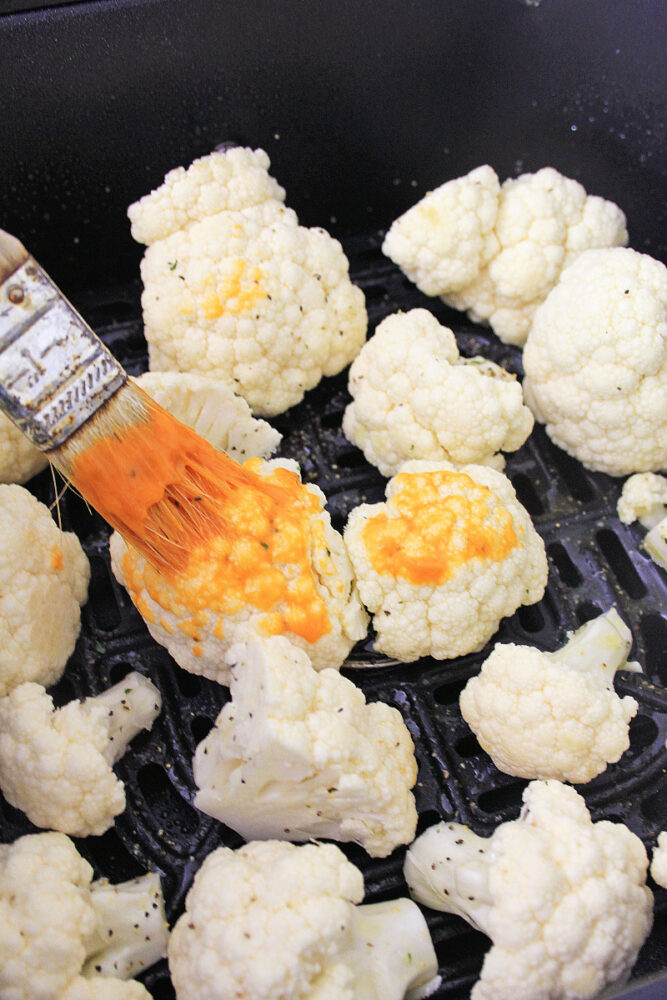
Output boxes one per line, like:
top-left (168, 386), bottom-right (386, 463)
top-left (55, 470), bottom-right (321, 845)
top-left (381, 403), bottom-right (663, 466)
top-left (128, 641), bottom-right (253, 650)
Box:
top-left (362, 471), bottom-right (520, 586)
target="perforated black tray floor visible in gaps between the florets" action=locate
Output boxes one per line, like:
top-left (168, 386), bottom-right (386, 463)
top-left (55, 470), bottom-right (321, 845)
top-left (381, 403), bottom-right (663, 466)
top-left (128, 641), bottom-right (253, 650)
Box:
top-left (0, 233), bottom-right (667, 1000)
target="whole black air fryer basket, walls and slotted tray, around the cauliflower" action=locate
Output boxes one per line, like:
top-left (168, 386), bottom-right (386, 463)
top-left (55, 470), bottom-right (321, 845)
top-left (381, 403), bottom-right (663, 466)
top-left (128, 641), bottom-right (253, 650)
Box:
top-left (0, 0), bottom-right (667, 1000)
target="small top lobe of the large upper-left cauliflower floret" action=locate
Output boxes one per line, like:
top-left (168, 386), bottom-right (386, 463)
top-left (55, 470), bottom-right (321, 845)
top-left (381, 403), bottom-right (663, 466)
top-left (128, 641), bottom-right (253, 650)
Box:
top-left (127, 146), bottom-right (285, 246)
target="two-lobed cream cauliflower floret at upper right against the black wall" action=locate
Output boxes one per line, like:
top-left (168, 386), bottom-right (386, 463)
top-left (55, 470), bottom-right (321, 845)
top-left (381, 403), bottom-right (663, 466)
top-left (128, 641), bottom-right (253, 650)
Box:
top-left (382, 165), bottom-right (628, 346)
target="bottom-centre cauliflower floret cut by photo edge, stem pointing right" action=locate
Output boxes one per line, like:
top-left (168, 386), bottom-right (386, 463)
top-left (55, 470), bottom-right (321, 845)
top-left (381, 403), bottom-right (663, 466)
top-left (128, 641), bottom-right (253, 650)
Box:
top-left (169, 840), bottom-right (440, 1000)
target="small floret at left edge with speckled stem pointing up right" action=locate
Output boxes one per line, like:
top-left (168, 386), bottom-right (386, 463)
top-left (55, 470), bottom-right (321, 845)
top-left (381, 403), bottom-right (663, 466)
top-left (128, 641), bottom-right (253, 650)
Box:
top-left (0, 673), bottom-right (162, 837)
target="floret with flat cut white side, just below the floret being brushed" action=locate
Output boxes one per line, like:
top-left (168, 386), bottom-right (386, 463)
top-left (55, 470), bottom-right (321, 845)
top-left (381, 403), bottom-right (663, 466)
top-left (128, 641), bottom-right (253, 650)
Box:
top-left (193, 636), bottom-right (417, 857)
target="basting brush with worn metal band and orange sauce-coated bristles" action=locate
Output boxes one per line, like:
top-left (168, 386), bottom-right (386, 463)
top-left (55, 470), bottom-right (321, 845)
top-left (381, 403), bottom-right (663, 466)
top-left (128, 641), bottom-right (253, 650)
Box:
top-left (0, 230), bottom-right (280, 572)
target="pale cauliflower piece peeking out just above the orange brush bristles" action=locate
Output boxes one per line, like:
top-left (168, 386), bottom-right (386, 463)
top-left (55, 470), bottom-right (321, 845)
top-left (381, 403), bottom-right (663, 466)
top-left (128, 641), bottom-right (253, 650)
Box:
top-left (134, 372), bottom-right (282, 462)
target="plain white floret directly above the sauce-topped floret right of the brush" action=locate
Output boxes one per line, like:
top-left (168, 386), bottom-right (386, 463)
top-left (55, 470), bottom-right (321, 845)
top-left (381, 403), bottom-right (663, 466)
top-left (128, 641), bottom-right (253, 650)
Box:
top-left (343, 309), bottom-right (534, 476)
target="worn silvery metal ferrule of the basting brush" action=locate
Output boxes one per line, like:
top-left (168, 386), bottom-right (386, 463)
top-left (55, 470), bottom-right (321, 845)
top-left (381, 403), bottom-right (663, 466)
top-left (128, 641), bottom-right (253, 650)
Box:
top-left (0, 257), bottom-right (127, 451)
